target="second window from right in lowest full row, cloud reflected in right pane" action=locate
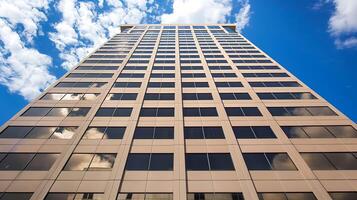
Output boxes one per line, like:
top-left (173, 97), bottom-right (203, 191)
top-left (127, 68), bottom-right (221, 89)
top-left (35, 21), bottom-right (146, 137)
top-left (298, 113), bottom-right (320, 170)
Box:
top-left (243, 153), bottom-right (297, 171)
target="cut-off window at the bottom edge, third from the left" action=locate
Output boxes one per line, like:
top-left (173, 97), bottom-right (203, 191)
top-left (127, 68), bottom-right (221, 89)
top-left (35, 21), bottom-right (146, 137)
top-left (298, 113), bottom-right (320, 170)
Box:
top-left (116, 193), bottom-right (173, 200)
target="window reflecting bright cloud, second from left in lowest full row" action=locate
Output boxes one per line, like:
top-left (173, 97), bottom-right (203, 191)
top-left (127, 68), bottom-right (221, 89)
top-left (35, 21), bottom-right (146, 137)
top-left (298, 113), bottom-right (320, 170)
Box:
top-left (63, 153), bottom-right (116, 171)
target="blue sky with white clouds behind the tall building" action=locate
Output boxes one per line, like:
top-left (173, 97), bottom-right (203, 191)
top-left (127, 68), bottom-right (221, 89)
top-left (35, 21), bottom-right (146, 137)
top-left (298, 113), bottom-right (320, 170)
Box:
top-left (0, 0), bottom-right (357, 124)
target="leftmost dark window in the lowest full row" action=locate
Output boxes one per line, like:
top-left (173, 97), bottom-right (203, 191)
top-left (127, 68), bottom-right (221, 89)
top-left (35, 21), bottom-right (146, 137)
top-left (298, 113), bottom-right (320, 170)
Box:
top-left (0, 153), bottom-right (59, 171)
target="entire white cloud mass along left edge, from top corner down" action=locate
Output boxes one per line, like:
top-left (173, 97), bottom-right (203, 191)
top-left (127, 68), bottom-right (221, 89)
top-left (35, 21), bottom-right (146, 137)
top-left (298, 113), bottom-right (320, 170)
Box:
top-left (0, 0), bottom-right (56, 100)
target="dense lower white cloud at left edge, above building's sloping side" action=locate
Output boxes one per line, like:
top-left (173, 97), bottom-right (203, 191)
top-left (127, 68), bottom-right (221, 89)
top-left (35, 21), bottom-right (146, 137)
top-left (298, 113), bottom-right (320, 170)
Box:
top-left (0, 19), bottom-right (56, 100)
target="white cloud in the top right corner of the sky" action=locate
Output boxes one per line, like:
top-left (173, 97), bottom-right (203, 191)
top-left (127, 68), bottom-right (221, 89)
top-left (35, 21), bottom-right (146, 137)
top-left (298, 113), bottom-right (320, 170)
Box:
top-left (329, 0), bottom-right (357, 48)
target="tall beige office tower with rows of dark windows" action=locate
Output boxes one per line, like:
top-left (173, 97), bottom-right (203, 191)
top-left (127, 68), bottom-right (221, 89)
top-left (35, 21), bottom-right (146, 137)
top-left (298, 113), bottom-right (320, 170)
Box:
top-left (0, 24), bottom-right (357, 200)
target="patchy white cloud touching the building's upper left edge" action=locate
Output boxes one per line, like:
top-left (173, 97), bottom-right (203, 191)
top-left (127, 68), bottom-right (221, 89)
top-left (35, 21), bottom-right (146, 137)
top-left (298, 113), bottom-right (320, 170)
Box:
top-left (50, 0), bottom-right (146, 69)
